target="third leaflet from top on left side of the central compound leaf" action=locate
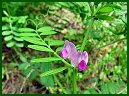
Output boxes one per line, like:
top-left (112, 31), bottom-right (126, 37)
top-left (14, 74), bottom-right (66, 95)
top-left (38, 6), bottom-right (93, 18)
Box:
top-left (21, 37), bottom-right (46, 45)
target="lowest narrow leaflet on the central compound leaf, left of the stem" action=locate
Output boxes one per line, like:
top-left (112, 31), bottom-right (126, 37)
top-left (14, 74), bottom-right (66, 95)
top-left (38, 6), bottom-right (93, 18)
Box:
top-left (40, 67), bottom-right (66, 77)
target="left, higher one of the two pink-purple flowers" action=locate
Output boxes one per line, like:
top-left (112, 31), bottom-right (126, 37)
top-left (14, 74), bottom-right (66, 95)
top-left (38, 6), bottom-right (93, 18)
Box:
top-left (59, 40), bottom-right (76, 59)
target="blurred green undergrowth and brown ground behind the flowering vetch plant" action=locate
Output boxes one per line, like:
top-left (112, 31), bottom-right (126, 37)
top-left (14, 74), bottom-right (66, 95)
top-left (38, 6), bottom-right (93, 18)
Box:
top-left (2, 2), bottom-right (127, 94)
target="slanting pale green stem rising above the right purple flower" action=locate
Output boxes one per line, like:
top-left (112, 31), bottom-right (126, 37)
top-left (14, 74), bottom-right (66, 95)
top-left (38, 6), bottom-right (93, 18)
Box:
top-left (80, 20), bottom-right (93, 51)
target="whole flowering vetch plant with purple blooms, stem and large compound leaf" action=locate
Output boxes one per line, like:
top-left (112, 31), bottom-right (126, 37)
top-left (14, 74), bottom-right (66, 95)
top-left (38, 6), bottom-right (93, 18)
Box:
top-left (19, 16), bottom-right (91, 94)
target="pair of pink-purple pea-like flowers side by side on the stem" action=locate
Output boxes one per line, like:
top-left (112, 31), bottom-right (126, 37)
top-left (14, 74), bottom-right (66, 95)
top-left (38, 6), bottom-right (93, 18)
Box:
top-left (59, 40), bottom-right (88, 71)
